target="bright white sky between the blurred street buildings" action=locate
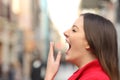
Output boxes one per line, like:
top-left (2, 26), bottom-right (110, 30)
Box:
top-left (47, 0), bottom-right (81, 37)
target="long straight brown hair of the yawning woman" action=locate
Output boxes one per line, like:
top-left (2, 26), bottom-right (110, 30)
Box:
top-left (82, 13), bottom-right (119, 80)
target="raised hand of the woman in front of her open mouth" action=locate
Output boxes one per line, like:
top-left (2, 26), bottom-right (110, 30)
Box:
top-left (45, 42), bottom-right (61, 80)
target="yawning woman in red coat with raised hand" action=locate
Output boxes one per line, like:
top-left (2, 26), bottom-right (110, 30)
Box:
top-left (45, 13), bottom-right (119, 80)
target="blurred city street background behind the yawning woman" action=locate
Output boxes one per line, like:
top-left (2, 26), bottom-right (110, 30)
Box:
top-left (0, 0), bottom-right (120, 80)
